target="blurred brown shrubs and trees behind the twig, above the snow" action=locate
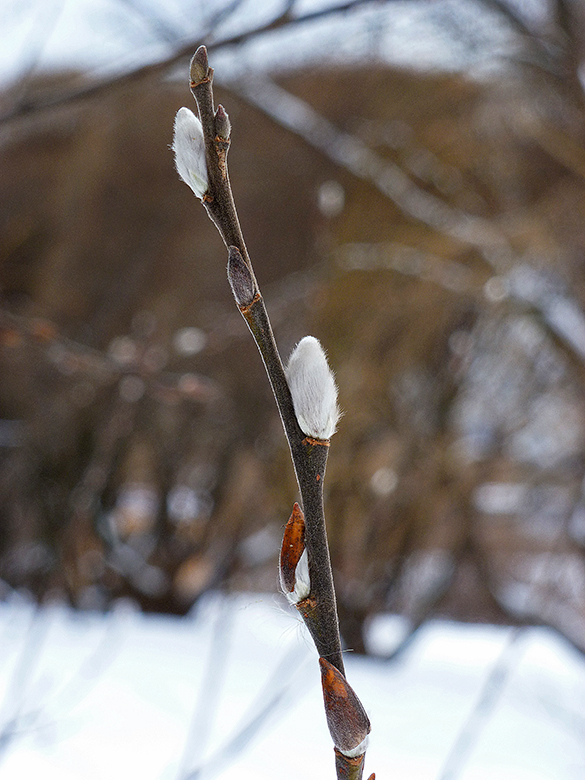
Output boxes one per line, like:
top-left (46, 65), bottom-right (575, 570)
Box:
top-left (0, 0), bottom-right (585, 652)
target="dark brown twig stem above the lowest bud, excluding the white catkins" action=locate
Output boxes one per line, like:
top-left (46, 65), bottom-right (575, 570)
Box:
top-left (190, 46), bottom-right (344, 674)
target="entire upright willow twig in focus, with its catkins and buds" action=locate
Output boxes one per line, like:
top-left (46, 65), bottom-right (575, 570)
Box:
top-left (173, 46), bottom-right (370, 780)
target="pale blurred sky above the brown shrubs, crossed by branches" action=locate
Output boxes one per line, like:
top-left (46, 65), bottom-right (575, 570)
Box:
top-left (0, 0), bottom-right (532, 89)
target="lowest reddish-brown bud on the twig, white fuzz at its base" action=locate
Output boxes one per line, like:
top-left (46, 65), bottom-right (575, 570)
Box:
top-left (319, 658), bottom-right (370, 758)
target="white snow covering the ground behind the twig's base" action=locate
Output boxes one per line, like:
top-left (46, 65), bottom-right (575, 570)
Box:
top-left (0, 594), bottom-right (585, 780)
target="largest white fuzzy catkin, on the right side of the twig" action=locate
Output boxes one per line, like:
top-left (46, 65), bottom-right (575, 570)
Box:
top-left (286, 336), bottom-right (339, 440)
